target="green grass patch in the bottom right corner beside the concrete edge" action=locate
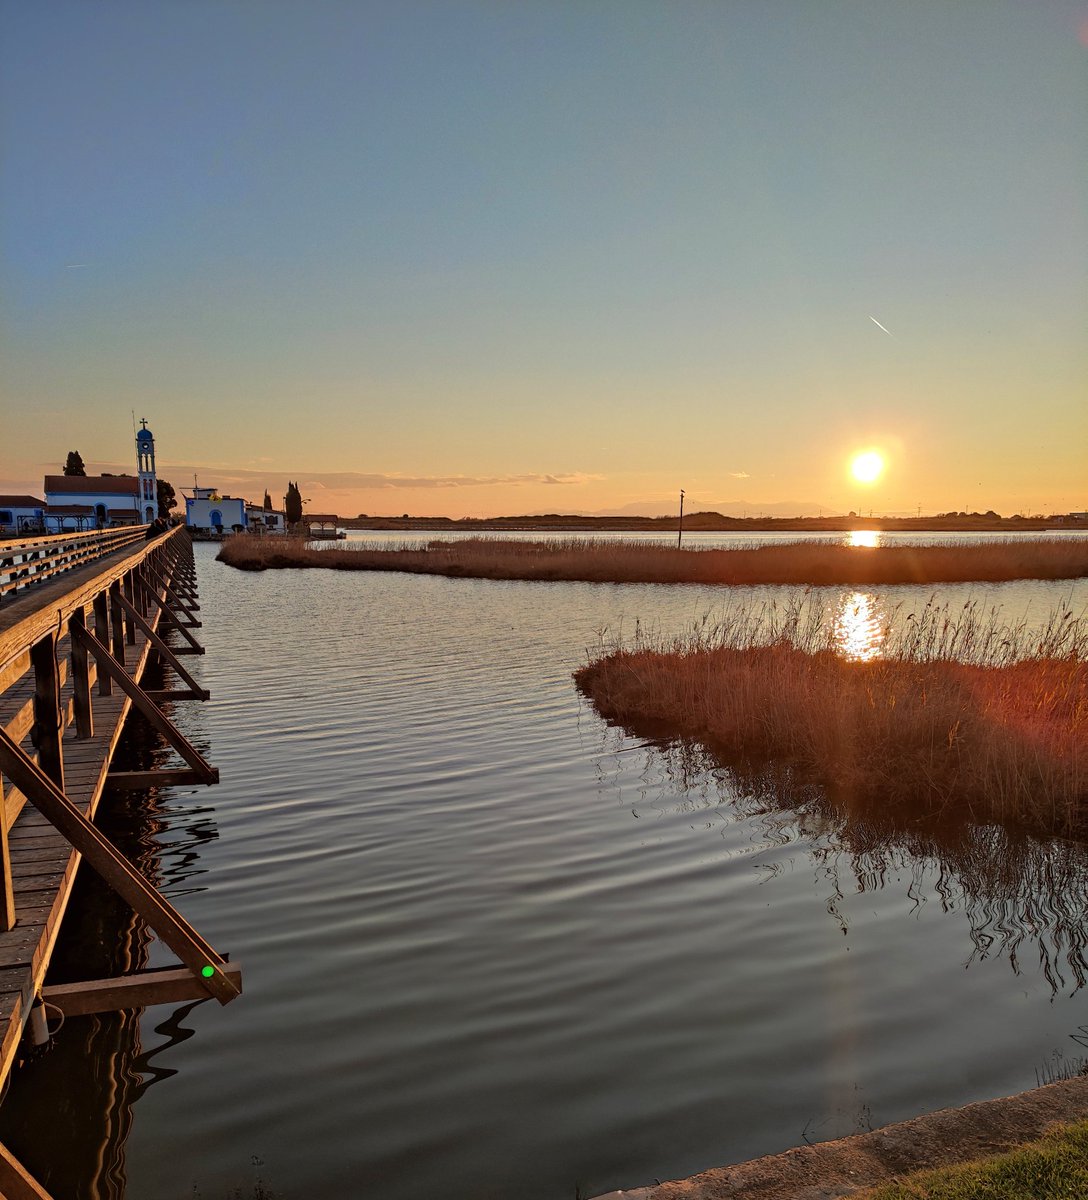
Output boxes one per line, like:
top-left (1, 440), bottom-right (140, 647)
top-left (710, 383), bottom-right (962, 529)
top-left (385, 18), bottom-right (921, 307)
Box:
top-left (855, 1121), bottom-right (1088, 1200)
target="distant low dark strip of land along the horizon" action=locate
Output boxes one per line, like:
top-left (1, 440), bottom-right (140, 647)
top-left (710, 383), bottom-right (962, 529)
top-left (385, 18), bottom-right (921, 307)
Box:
top-left (337, 511), bottom-right (1088, 533)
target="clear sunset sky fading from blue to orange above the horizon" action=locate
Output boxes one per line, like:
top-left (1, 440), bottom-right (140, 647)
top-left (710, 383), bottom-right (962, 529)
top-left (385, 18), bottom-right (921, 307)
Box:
top-left (0, 0), bottom-right (1088, 516)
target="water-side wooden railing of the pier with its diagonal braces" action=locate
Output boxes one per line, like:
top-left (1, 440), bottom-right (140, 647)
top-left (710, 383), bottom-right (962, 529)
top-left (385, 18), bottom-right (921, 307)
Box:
top-left (0, 527), bottom-right (239, 1003)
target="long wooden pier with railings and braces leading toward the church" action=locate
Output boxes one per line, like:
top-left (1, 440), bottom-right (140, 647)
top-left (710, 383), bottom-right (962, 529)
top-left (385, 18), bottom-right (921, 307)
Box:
top-left (0, 527), bottom-right (241, 1200)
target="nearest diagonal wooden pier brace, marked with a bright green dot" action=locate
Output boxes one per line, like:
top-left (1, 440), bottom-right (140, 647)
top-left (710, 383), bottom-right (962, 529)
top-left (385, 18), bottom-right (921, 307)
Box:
top-left (0, 724), bottom-right (240, 1004)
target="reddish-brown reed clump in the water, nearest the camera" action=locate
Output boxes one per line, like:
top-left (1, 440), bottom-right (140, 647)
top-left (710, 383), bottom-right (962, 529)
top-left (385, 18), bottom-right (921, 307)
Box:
top-left (575, 598), bottom-right (1088, 836)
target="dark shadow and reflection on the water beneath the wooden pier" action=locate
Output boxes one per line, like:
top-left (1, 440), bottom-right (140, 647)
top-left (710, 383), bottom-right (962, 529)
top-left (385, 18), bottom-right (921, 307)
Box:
top-left (0, 683), bottom-right (218, 1200)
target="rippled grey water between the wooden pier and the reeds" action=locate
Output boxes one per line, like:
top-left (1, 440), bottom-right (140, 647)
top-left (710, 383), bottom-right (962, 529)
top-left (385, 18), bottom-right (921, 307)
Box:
top-left (2, 535), bottom-right (1088, 1200)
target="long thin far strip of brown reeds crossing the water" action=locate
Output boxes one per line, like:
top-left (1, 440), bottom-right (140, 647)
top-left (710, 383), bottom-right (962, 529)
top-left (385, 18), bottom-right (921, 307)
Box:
top-left (218, 536), bottom-right (1088, 587)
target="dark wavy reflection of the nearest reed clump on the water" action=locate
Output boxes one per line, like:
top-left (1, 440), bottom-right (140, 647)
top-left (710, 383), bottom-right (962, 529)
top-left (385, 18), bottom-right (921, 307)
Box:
top-left (606, 728), bottom-right (1088, 1003)
